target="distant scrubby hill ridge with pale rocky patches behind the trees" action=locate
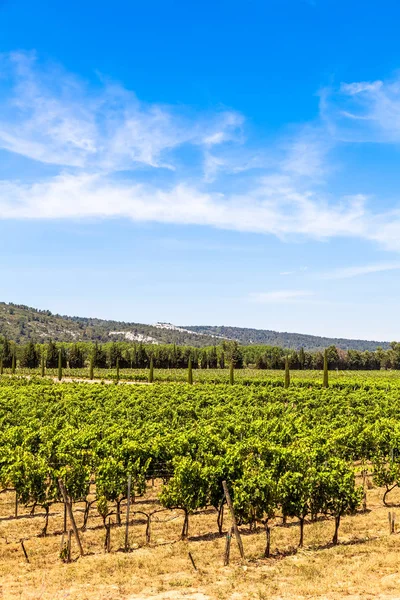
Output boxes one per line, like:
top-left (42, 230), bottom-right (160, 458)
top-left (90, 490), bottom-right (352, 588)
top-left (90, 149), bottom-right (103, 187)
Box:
top-left (0, 302), bottom-right (389, 351)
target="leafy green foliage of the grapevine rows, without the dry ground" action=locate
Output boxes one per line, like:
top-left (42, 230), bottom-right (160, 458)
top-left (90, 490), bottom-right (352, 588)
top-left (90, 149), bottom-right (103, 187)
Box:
top-left (0, 378), bottom-right (392, 555)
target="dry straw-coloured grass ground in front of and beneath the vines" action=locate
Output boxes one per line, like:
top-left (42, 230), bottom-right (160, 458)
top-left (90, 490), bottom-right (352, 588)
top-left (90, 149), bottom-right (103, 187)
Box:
top-left (0, 480), bottom-right (400, 600)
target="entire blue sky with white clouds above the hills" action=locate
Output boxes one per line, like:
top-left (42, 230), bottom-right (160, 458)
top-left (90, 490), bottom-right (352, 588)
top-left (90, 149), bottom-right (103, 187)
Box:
top-left (0, 0), bottom-right (400, 340)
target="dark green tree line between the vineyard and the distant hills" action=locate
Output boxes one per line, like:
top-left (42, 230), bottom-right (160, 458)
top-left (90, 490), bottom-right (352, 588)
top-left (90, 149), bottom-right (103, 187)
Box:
top-left (0, 338), bottom-right (400, 370)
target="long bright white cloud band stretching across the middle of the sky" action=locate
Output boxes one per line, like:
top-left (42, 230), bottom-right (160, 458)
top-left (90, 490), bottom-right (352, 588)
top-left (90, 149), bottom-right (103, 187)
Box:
top-left (0, 173), bottom-right (376, 239)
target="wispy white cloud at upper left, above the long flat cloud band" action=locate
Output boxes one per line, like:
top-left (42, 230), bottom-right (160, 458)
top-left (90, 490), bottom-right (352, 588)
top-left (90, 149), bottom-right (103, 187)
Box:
top-left (0, 53), bottom-right (243, 171)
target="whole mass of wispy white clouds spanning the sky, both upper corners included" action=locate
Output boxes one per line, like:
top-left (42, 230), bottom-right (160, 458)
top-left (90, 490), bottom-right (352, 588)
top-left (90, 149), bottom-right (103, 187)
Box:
top-left (0, 53), bottom-right (400, 251)
